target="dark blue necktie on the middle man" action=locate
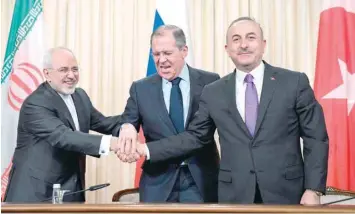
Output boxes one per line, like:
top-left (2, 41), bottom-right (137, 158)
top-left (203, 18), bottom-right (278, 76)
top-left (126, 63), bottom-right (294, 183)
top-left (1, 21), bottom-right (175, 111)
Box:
top-left (169, 77), bottom-right (184, 133)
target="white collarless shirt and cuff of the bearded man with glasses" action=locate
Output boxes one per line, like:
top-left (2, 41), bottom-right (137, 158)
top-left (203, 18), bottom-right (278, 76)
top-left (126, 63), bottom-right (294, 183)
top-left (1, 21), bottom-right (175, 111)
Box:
top-left (58, 93), bottom-right (111, 155)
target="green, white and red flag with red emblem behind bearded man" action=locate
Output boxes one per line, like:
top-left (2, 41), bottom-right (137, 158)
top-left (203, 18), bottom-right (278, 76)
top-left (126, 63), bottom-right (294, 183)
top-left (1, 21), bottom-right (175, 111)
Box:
top-left (1, 0), bottom-right (44, 197)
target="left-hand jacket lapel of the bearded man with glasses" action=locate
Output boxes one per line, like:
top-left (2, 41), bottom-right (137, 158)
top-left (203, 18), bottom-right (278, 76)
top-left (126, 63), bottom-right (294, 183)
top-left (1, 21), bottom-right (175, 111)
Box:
top-left (43, 82), bottom-right (76, 130)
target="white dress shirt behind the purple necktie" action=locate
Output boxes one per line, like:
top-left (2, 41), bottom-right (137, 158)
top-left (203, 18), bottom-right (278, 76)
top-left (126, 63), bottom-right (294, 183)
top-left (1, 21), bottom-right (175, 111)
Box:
top-left (235, 62), bottom-right (265, 122)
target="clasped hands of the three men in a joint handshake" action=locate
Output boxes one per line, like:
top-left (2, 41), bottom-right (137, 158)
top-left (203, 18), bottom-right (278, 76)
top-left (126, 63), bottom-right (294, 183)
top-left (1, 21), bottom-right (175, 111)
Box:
top-left (110, 123), bottom-right (147, 163)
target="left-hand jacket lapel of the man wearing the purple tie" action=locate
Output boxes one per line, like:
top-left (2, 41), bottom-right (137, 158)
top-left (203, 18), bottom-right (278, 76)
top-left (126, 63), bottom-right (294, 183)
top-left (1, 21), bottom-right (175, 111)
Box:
top-left (224, 71), bottom-right (252, 138)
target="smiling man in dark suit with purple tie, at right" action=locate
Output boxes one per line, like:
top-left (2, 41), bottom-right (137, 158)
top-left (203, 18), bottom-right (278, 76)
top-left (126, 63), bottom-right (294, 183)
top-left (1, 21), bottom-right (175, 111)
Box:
top-left (121, 17), bottom-right (328, 204)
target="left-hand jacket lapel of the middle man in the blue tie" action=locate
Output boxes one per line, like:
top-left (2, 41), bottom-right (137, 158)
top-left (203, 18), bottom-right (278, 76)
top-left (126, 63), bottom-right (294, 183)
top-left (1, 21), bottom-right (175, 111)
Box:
top-left (151, 74), bottom-right (177, 134)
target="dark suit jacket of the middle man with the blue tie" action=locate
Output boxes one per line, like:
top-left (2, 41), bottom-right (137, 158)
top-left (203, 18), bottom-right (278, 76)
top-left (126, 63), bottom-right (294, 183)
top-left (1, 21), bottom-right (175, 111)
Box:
top-left (122, 67), bottom-right (219, 202)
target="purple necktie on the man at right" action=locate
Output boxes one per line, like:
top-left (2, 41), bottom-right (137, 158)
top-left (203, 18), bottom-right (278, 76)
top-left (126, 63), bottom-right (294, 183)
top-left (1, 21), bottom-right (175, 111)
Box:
top-left (244, 74), bottom-right (258, 136)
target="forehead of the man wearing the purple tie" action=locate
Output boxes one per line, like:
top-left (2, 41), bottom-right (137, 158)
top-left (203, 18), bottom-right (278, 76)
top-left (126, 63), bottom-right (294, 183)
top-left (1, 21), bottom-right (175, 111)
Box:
top-left (227, 20), bottom-right (261, 37)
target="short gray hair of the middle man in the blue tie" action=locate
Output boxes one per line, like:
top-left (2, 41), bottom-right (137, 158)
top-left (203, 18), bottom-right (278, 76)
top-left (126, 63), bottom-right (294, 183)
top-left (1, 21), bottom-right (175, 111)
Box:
top-left (150, 25), bottom-right (186, 49)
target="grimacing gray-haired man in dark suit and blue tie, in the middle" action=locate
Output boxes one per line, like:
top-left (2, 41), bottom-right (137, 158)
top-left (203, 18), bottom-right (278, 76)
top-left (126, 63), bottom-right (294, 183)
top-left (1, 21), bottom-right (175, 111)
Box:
top-left (120, 25), bottom-right (219, 203)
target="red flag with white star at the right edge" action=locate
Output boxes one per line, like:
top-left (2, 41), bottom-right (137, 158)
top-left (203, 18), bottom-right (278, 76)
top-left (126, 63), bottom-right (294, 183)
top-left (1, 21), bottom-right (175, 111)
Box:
top-left (314, 0), bottom-right (355, 192)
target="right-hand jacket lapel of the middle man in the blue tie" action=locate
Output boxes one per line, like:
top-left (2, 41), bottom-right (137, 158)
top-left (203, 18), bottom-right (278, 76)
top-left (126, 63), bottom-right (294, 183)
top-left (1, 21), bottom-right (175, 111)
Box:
top-left (185, 66), bottom-right (204, 128)
